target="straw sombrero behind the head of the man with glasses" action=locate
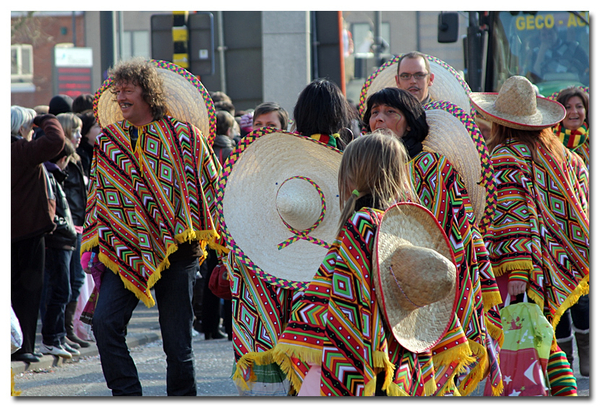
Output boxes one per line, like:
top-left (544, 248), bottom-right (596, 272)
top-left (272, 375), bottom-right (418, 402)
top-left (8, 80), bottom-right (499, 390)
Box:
top-left (358, 54), bottom-right (471, 117)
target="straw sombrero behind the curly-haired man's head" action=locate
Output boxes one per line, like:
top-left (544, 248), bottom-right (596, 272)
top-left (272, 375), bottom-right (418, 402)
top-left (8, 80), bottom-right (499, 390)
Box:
top-left (94, 59), bottom-right (217, 144)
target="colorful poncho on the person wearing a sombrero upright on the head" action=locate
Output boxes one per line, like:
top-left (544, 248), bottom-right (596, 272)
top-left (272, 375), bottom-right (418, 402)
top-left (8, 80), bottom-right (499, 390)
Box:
top-left (486, 140), bottom-right (589, 328)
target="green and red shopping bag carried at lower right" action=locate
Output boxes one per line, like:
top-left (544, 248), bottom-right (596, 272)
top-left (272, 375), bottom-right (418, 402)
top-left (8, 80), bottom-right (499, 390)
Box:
top-left (484, 295), bottom-right (554, 397)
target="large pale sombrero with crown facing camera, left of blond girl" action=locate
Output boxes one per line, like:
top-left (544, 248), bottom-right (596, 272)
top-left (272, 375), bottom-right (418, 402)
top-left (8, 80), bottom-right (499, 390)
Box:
top-left (217, 128), bottom-right (342, 288)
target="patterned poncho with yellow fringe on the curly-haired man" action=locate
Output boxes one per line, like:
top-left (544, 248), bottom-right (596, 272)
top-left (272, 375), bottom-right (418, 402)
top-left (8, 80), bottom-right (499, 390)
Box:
top-left (81, 117), bottom-right (220, 307)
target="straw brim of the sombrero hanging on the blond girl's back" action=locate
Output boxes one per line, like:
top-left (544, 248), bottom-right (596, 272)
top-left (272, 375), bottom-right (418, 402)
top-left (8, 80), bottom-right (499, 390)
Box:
top-left (373, 203), bottom-right (458, 353)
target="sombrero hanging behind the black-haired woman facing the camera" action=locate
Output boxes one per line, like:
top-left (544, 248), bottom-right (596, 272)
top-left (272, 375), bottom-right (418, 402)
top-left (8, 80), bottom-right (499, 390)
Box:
top-left (423, 102), bottom-right (496, 233)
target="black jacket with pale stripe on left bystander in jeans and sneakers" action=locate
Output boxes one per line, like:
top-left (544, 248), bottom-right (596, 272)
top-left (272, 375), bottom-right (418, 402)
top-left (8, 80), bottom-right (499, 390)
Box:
top-left (44, 162), bottom-right (77, 250)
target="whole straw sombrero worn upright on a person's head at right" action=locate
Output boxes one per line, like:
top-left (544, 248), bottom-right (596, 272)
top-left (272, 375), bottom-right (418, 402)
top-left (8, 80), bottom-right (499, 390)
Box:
top-left (470, 75), bottom-right (566, 130)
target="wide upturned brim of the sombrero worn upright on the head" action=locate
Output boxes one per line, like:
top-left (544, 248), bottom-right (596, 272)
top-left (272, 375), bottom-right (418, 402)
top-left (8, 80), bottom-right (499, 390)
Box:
top-left (470, 92), bottom-right (566, 130)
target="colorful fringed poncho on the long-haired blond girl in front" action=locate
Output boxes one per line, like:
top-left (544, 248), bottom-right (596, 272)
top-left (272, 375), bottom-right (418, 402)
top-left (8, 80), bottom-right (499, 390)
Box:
top-left (274, 208), bottom-right (470, 396)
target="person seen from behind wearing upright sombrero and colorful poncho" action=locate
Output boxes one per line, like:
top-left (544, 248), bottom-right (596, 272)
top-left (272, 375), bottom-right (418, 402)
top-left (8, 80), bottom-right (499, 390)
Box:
top-left (471, 76), bottom-right (589, 395)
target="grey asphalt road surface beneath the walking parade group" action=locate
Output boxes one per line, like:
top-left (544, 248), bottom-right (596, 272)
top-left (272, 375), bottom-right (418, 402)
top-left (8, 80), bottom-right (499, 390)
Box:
top-left (11, 303), bottom-right (590, 401)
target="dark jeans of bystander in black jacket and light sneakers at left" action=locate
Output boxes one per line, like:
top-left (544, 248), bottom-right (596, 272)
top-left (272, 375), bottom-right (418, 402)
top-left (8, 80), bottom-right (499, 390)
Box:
top-left (42, 248), bottom-right (73, 346)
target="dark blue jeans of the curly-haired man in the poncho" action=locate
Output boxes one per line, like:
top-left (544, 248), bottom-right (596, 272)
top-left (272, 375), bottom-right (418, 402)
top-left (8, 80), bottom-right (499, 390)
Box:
top-left (92, 258), bottom-right (198, 396)
